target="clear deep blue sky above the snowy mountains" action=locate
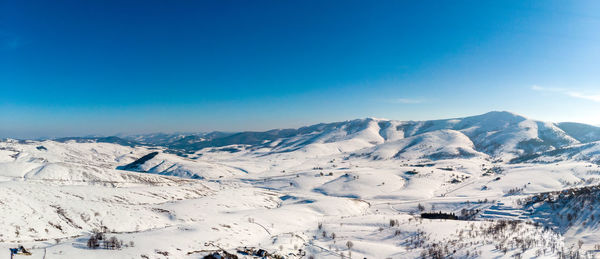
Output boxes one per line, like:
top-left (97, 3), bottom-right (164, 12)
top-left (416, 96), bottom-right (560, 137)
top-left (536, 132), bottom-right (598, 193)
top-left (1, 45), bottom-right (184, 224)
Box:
top-left (0, 0), bottom-right (600, 138)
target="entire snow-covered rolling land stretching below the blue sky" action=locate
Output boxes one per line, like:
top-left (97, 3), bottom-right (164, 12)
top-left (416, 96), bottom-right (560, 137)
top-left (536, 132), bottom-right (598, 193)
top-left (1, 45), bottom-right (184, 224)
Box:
top-left (0, 112), bottom-right (600, 258)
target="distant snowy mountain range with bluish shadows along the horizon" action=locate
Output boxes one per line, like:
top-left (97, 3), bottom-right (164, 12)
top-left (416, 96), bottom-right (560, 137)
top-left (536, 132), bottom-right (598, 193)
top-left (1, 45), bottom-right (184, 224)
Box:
top-left (45, 111), bottom-right (600, 164)
